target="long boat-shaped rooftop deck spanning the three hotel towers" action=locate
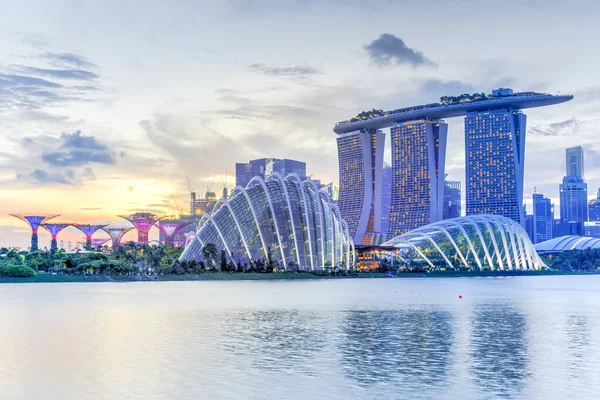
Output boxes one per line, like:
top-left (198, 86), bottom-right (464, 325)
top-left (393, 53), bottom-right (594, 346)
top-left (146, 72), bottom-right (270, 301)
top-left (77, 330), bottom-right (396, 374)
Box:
top-left (333, 88), bottom-right (573, 134)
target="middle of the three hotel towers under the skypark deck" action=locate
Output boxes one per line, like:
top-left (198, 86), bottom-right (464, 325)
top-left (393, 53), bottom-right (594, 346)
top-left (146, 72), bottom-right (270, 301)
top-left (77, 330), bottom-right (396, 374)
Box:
top-left (387, 120), bottom-right (448, 239)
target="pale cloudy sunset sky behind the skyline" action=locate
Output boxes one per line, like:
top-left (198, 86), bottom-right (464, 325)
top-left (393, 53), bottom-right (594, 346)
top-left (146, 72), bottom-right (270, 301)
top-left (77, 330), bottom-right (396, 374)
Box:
top-left (0, 0), bottom-right (600, 248)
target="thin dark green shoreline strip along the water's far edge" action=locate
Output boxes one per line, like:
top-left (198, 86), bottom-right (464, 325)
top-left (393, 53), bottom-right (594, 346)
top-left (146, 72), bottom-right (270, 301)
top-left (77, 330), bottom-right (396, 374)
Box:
top-left (0, 270), bottom-right (600, 284)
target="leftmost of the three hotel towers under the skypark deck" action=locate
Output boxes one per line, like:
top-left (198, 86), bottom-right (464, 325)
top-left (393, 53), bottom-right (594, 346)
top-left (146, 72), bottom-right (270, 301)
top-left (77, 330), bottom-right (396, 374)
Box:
top-left (337, 129), bottom-right (385, 245)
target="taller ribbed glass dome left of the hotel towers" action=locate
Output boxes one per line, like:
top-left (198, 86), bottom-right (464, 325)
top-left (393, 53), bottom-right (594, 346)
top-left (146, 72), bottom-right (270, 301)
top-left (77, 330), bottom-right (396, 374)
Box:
top-left (180, 173), bottom-right (355, 270)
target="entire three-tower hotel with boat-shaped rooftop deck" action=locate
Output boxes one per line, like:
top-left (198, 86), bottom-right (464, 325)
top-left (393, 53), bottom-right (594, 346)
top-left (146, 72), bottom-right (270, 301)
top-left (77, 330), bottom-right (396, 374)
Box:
top-left (333, 88), bottom-right (573, 245)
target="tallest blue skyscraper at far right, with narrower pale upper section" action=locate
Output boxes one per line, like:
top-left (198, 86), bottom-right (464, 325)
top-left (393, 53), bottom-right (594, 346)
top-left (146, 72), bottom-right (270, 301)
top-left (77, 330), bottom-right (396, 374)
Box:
top-left (559, 146), bottom-right (588, 235)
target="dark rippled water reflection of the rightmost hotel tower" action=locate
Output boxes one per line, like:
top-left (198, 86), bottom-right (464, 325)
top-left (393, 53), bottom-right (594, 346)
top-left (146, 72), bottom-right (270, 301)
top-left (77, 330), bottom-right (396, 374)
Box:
top-left (469, 304), bottom-right (530, 397)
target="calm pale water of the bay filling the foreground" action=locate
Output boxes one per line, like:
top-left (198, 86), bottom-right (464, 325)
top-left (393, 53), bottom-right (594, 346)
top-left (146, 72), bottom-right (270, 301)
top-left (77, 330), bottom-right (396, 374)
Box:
top-left (0, 276), bottom-right (600, 399)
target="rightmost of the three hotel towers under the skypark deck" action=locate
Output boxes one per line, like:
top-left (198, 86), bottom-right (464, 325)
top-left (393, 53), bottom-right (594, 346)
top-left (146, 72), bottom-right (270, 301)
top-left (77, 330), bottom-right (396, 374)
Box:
top-left (465, 108), bottom-right (527, 224)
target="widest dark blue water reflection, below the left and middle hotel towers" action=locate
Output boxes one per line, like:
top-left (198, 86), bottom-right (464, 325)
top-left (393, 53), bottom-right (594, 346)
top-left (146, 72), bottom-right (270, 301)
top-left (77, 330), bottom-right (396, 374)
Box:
top-left (338, 310), bottom-right (452, 389)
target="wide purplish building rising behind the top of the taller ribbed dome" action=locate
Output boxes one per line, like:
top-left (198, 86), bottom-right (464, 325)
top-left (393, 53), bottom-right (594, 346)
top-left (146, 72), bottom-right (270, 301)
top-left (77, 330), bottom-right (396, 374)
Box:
top-left (235, 158), bottom-right (306, 188)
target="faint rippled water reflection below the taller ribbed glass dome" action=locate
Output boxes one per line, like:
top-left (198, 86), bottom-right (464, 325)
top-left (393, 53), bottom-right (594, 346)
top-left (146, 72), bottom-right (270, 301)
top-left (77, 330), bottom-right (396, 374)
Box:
top-left (221, 310), bottom-right (326, 376)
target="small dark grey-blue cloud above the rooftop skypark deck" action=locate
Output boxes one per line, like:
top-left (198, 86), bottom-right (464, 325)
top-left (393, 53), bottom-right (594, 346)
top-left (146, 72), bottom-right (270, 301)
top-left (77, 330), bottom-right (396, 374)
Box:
top-left (363, 33), bottom-right (433, 67)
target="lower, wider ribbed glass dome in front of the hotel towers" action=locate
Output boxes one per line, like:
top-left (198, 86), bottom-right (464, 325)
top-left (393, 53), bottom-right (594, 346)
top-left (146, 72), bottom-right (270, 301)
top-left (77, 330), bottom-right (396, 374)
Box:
top-left (383, 215), bottom-right (545, 270)
